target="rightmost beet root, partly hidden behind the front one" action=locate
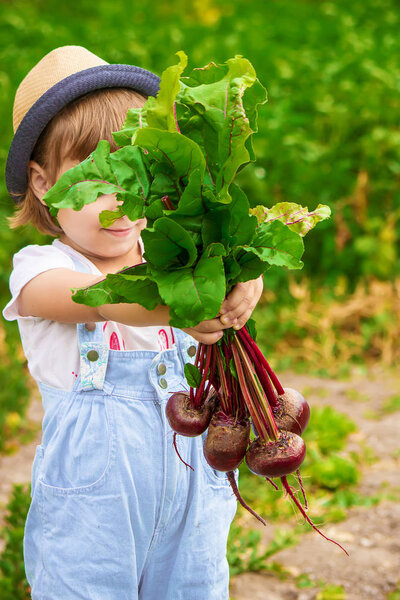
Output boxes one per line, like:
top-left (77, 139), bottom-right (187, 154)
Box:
top-left (272, 388), bottom-right (310, 435)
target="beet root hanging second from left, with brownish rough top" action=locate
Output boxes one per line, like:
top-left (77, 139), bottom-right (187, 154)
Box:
top-left (203, 411), bottom-right (250, 471)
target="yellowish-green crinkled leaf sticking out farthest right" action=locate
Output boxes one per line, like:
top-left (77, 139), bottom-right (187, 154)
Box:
top-left (250, 202), bottom-right (331, 236)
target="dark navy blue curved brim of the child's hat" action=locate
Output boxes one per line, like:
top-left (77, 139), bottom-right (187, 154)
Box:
top-left (5, 64), bottom-right (160, 203)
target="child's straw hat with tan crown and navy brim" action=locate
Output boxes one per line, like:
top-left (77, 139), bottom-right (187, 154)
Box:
top-left (6, 46), bottom-right (160, 202)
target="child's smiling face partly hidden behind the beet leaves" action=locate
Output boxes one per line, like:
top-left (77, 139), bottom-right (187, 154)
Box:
top-left (57, 159), bottom-right (146, 264)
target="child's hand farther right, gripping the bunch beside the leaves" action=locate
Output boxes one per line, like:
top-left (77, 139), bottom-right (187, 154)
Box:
top-left (219, 276), bottom-right (263, 329)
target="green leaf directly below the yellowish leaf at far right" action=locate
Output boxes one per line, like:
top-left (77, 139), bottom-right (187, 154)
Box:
top-left (241, 221), bottom-right (304, 269)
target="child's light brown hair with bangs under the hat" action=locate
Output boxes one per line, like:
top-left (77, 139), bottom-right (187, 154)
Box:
top-left (8, 88), bottom-right (147, 237)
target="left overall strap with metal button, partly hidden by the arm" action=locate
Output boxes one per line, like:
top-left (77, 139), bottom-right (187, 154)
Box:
top-left (70, 251), bottom-right (109, 391)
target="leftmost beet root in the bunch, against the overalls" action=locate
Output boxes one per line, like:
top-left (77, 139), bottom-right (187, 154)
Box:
top-left (165, 392), bottom-right (214, 437)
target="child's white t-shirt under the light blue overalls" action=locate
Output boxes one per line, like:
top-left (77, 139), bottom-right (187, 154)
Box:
top-left (3, 240), bottom-right (174, 390)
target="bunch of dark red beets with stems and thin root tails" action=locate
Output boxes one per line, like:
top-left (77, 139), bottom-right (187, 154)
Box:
top-left (166, 326), bottom-right (347, 554)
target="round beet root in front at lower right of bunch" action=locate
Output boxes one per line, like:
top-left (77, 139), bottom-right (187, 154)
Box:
top-left (246, 431), bottom-right (306, 477)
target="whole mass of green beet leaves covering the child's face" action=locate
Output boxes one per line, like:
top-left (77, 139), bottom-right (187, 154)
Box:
top-left (44, 52), bottom-right (330, 328)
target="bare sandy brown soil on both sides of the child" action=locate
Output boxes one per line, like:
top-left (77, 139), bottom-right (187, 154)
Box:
top-left (0, 368), bottom-right (400, 600)
